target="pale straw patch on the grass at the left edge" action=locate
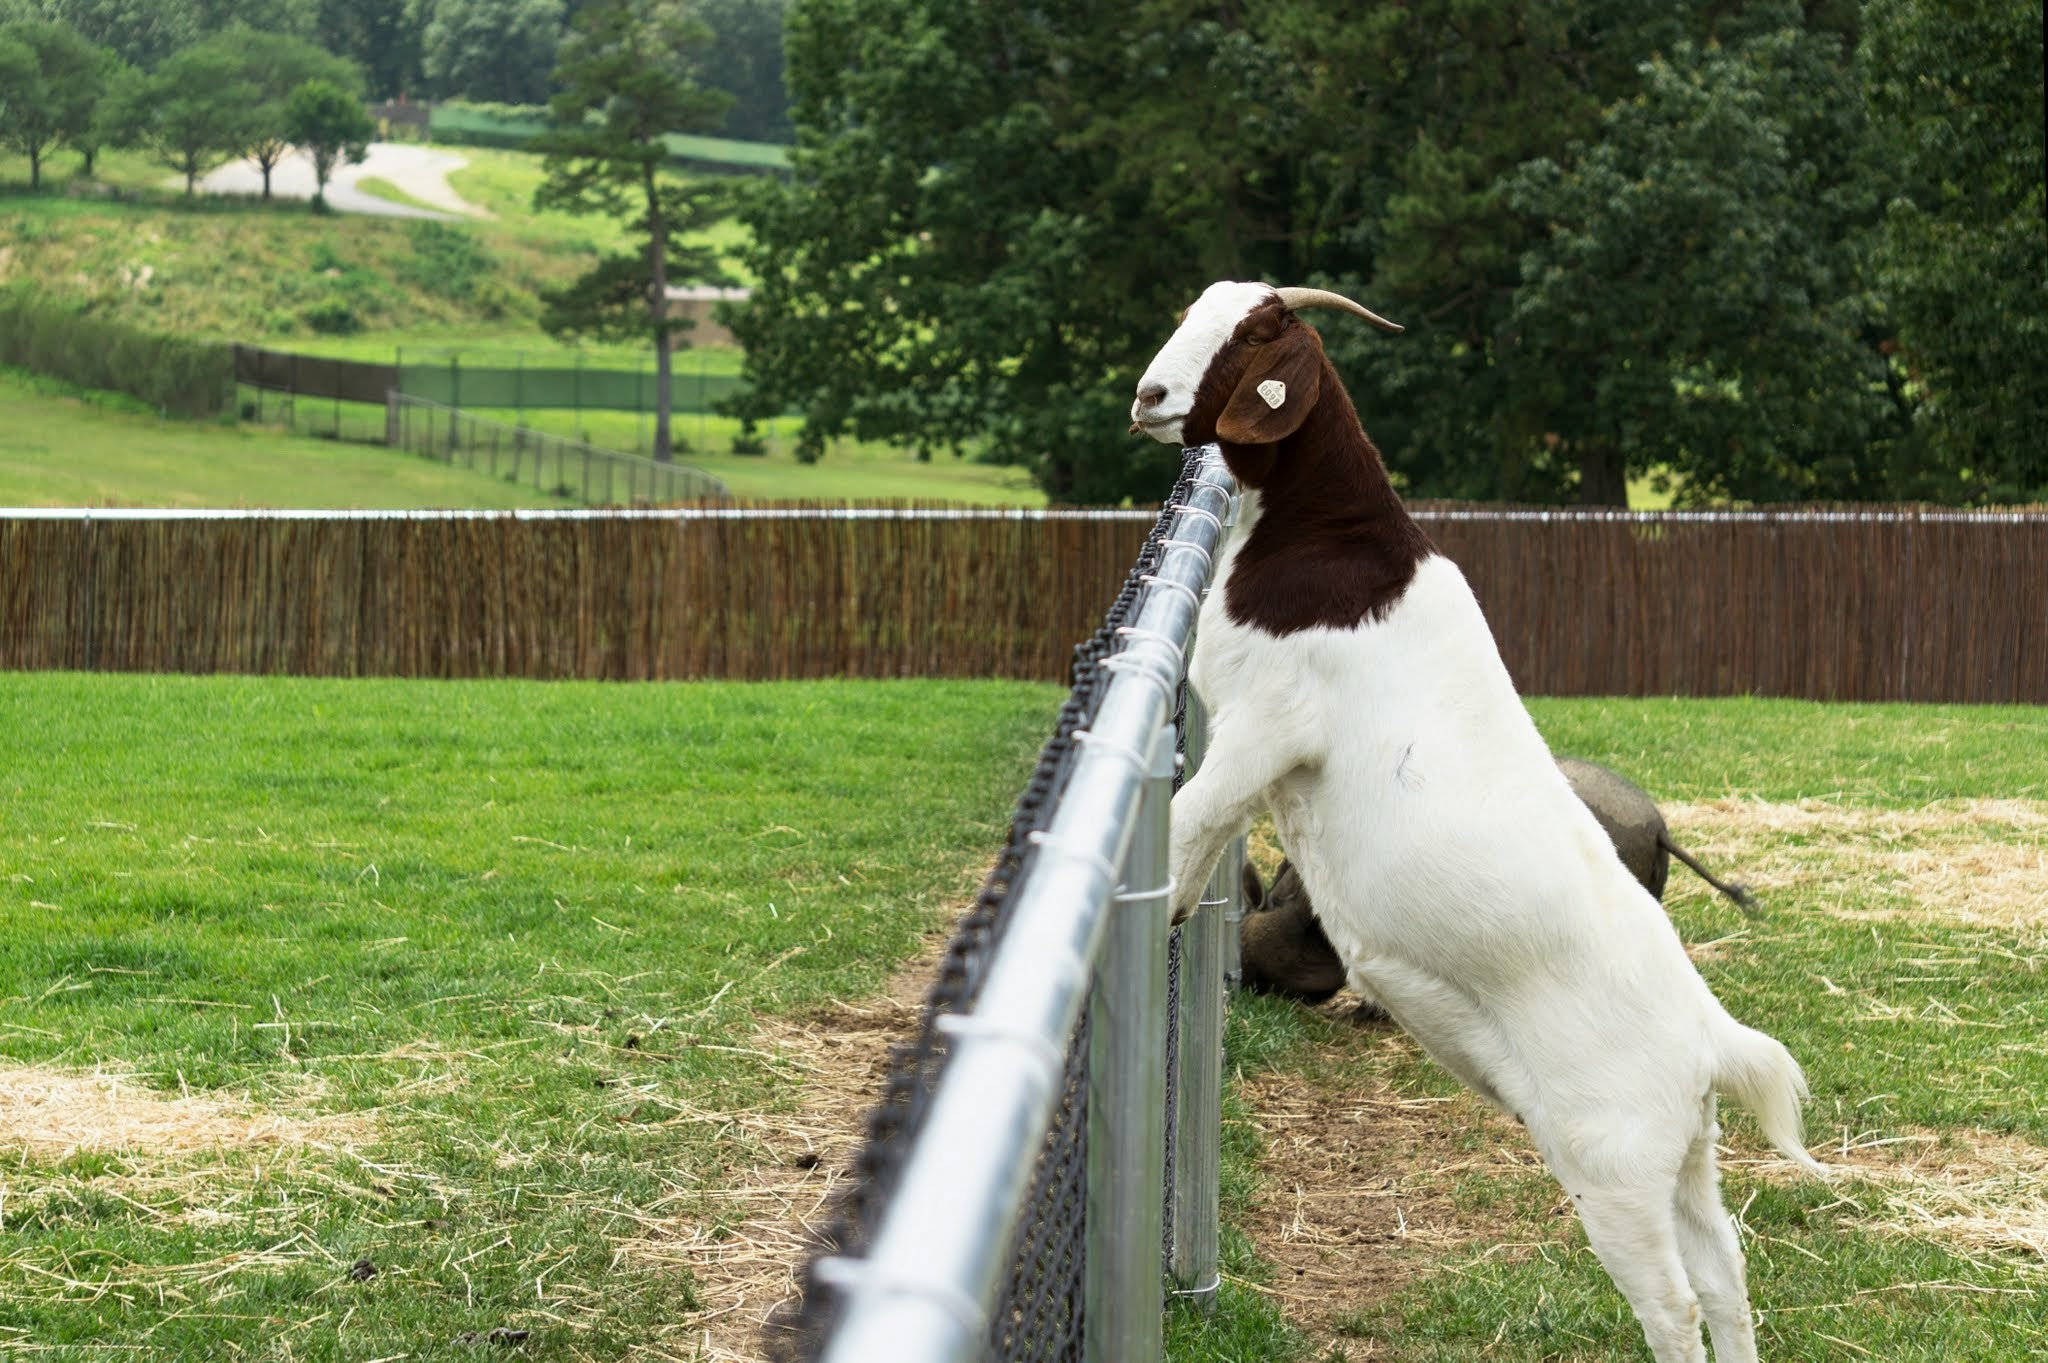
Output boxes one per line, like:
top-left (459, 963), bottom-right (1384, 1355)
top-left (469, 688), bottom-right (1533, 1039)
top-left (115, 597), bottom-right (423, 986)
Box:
top-left (0, 1068), bottom-right (365, 1162)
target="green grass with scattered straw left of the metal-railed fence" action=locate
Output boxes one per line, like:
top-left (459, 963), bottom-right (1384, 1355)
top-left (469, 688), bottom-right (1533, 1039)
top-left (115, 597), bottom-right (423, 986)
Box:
top-left (0, 673), bottom-right (1061, 1361)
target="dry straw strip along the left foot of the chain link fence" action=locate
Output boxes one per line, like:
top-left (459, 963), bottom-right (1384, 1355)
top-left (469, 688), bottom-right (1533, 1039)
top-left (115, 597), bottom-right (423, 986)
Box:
top-left (602, 937), bottom-right (944, 1363)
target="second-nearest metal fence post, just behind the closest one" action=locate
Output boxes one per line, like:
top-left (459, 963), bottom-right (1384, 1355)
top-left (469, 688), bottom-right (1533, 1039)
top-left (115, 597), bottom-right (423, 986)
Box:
top-left (1167, 691), bottom-right (1245, 1312)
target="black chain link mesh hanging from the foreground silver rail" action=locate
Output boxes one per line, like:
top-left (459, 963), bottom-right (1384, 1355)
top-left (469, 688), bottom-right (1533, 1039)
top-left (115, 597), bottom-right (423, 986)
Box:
top-left (774, 454), bottom-right (1200, 1363)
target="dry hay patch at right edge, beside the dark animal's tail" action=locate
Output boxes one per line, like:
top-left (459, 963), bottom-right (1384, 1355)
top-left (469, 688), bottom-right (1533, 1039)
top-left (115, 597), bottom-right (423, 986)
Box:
top-left (1663, 800), bottom-right (2048, 931)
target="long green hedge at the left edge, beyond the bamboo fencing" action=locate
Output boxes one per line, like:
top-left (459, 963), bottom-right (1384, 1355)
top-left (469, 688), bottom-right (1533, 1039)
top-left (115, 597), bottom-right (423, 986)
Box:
top-left (0, 287), bottom-right (236, 417)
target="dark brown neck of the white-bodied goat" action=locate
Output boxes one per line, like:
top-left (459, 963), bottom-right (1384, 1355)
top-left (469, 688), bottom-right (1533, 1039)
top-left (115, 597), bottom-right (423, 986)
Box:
top-left (1223, 360), bottom-right (1436, 634)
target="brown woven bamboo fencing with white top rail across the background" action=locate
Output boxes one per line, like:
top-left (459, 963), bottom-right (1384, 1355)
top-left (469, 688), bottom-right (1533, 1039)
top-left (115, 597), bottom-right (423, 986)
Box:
top-left (0, 508), bottom-right (2048, 704)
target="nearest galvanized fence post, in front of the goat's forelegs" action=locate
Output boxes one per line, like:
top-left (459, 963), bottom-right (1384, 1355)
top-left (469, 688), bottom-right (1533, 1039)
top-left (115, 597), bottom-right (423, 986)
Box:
top-left (1081, 727), bottom-right (1174, 1363)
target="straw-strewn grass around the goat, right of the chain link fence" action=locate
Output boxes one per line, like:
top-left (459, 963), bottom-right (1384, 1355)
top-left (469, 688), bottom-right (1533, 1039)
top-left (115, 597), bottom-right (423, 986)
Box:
top-left (1174, 700), bottom-right (2048, 1363)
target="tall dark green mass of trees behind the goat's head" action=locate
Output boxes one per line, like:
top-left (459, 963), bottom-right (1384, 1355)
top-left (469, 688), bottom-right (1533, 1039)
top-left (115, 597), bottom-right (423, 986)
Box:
top-left (735, 0), bottom-right (2048, 505)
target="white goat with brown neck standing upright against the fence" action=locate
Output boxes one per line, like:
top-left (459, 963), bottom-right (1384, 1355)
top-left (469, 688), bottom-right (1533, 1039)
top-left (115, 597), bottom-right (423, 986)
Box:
top-left (1130, 282), bottom-right (1819, 1363)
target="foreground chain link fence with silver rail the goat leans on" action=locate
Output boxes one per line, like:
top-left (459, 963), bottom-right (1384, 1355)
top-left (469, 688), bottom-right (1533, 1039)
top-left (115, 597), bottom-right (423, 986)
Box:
top-left (776, 446), bottom-right (1235, 1363)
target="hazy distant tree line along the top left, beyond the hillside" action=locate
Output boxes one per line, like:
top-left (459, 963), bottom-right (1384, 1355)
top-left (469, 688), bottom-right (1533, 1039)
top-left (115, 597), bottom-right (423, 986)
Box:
top-left (0, 0), bottom-right (788, 141)
